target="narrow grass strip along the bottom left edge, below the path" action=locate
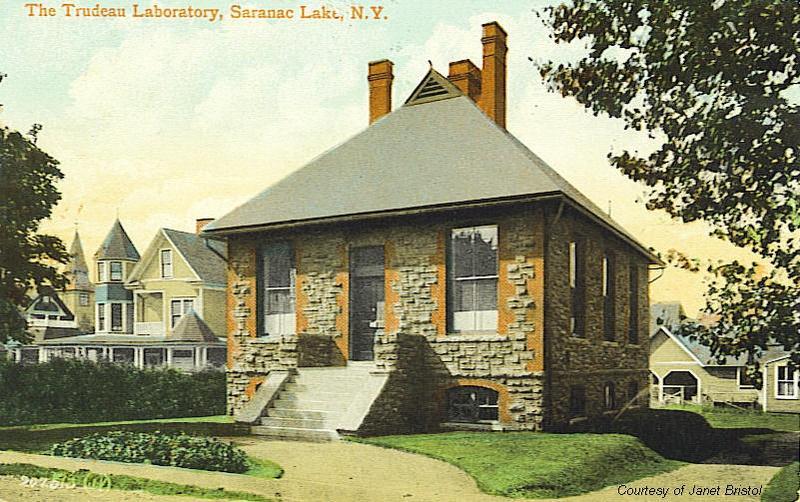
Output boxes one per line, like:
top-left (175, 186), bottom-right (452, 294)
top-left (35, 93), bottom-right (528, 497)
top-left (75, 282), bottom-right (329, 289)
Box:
top-left (0, 464), bottom-right (271, 502)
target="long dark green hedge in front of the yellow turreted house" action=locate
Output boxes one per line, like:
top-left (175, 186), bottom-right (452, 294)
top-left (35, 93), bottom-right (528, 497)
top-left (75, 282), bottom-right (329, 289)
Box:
top-left (0, 359), bottom-right (225, 425)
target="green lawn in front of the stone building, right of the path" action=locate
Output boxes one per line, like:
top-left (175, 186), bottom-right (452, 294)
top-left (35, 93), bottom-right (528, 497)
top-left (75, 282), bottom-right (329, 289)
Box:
top-left (355, 432), bottom-right (684, 498)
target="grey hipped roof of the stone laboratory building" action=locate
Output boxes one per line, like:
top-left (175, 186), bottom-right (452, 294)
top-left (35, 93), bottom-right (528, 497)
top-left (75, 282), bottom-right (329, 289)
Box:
top-left (204, 85), bottom-right (658, 261)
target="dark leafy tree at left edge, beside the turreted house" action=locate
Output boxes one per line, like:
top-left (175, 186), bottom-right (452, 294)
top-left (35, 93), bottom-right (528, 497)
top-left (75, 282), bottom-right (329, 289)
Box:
top-left (0, 106), bottom-right (69, 343)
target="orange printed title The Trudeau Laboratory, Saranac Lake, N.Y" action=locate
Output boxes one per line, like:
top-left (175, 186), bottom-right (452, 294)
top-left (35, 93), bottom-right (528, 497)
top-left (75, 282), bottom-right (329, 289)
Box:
top-left (23, 2), bottom-right (389, 22)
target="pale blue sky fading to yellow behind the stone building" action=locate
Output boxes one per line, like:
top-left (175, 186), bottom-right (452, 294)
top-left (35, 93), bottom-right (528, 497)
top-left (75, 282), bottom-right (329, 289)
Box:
top-left (0, 0), bottom-right (756, 313)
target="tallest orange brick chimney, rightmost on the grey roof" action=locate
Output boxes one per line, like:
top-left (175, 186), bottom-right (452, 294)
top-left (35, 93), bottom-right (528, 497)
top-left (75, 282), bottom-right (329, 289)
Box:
top-left (479, 21), bottom-right (508, 128)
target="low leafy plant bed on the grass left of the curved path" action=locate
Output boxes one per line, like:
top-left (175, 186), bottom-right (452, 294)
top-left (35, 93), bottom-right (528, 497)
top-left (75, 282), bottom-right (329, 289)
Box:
top-left (50, 431), bottom-right (249, 473)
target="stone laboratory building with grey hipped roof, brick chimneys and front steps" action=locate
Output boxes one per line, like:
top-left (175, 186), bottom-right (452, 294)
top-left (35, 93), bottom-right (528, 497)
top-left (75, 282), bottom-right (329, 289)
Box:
top-left (205, 22), bottom-right (657, 439)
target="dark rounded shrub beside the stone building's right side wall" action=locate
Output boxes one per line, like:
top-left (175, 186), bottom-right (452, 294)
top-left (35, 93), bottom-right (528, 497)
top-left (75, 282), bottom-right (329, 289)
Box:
top-left (568, 408), bottom-right (723, 462)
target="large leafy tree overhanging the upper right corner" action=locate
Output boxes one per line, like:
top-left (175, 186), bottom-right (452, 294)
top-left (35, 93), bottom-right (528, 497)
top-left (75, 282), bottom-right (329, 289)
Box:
top-left (538, 0), bottom-right (800, 378)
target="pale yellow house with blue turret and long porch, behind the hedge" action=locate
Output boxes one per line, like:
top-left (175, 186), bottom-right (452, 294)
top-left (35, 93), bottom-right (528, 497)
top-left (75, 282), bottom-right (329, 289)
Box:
top-left (13, 220), bottom-right (226, 371)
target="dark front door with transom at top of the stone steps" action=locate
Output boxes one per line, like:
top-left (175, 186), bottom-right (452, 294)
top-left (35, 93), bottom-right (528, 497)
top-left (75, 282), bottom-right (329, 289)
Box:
top-left (350, 246), bottom-right (384, 361)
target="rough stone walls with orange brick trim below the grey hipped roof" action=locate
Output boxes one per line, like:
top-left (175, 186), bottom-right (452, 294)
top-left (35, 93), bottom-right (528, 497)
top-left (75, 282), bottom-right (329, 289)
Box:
top-left (223, 204), bottom-right (648, 432)
